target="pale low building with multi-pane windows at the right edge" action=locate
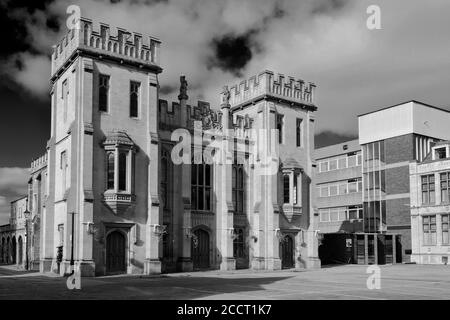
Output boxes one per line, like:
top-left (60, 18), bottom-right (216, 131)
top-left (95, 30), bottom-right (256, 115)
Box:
top-left (409, 141), bottom-right (450, 264)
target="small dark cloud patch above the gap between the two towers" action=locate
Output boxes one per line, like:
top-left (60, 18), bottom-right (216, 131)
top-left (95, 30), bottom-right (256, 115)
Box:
top-left (209, 31), bottom-right (260, 75)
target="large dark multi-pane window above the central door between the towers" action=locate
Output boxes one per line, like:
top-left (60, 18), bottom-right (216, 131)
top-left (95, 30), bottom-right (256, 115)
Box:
top-left (191, 164), bottom-right (211, 210)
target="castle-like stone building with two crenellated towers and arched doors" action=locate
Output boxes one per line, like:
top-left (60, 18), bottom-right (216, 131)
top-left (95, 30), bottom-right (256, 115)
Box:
top-left (39, 18), bottom-right (320, 276)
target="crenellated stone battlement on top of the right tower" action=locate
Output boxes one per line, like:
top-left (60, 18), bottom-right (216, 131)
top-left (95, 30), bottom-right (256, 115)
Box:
top-left (221, 70), bottom-right (316, 107)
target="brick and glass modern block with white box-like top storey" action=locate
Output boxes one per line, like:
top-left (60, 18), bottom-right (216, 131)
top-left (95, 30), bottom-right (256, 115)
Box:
top-left (358, 101), bottom-right (450, 262)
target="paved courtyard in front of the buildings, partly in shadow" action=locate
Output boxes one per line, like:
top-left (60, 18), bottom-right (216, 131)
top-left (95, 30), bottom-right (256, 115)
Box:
top-left (0, 265), bottom-right (450, 300)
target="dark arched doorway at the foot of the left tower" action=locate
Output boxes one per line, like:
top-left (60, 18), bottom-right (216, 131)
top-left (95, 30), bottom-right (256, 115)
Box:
top-left (106, 230), bottom-right (127, 273)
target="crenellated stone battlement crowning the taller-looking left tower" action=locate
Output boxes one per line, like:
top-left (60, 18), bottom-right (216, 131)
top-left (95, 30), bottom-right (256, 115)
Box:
top-left (52, 18), bottom-right (161, 78)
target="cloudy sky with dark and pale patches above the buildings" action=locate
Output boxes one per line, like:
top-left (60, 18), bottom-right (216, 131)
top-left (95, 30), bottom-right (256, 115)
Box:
top-left (0, 0), bottom-right (450, 224)
